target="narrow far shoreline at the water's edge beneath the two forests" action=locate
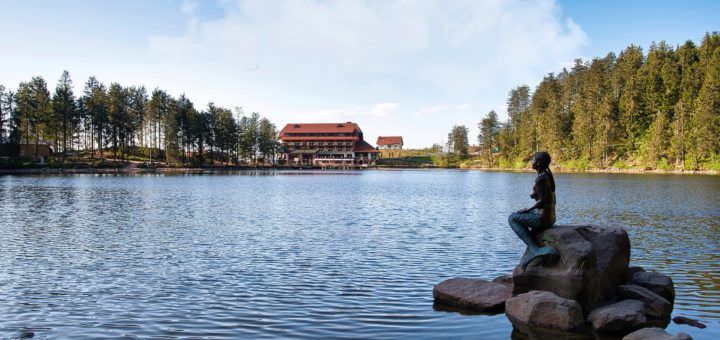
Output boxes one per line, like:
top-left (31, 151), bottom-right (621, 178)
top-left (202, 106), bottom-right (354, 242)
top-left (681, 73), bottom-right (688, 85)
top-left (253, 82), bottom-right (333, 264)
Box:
top-left (0, 166), bottom-right (720, 176)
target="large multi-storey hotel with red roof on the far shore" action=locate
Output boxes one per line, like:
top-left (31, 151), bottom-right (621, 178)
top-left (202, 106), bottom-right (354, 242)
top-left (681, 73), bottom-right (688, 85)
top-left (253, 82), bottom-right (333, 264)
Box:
top-left (280, 122), bottom-right (377, 167)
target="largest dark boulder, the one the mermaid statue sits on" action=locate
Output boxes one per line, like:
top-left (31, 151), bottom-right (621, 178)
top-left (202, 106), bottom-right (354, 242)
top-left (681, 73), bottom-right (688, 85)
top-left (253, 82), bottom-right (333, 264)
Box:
top-left (513, 225), bottom-right (630, 310)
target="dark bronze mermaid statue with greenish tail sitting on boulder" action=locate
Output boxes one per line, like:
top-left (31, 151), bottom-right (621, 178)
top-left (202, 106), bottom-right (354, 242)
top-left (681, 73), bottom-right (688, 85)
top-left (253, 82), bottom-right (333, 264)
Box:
top-left (508, 151), bottom-right (559, 270)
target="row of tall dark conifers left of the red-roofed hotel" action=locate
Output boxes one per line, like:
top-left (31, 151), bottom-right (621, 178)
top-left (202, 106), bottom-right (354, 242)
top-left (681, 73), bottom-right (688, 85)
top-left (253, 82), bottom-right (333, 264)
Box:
top-left (0, 71), bottom-right (281, 164)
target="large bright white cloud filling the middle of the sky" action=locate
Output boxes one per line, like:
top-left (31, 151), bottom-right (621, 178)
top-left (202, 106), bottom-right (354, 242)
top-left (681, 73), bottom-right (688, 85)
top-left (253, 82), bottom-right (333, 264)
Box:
top-left (147, 0), bottom-right (588, 146)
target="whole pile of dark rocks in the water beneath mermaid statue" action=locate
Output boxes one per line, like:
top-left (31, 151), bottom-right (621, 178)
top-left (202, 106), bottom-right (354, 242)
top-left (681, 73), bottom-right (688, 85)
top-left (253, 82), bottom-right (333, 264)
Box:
top-left (433, 226), bottom-right (682, 339)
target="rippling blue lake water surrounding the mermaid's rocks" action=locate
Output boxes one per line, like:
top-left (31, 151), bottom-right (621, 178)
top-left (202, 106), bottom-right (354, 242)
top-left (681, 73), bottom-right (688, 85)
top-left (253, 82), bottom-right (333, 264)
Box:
top-left (0, 170), bottom-right (720, 339)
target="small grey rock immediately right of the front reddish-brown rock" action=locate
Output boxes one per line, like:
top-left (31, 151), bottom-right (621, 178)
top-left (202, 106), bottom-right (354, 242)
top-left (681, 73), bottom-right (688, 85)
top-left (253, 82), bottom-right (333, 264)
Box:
top-left (588, 300), bottom-right (647, 333)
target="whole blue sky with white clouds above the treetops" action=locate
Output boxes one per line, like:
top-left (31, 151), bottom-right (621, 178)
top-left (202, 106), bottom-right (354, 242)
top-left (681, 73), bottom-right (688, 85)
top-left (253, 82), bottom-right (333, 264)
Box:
top-left (0, 0), bottom-right (720, 148)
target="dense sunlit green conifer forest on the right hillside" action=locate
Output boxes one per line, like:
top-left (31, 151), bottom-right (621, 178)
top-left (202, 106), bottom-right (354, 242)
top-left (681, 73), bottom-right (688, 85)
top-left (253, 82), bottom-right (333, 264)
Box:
top-left (448, 32), bottom-right (720, 170)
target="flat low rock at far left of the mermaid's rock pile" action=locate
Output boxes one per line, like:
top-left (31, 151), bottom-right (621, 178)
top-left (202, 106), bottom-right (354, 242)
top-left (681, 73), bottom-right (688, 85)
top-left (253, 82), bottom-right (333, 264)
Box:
top-left (433, 278), bottom-right (512, 313)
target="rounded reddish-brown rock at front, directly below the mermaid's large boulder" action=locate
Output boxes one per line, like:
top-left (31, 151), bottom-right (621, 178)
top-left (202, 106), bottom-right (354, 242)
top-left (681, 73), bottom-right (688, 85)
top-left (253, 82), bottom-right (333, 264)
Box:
top-left (505, 291), bottom-right (586, 335)
